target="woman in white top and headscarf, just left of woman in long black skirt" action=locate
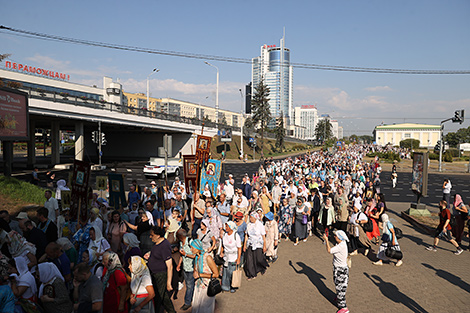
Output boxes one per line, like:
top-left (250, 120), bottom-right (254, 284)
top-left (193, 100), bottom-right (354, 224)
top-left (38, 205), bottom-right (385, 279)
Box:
top-left (220, 221), bottom-right (242, 293)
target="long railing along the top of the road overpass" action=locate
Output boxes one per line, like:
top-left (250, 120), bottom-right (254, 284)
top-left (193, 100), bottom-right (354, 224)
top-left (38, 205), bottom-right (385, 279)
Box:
top-left (24, 87), bottom-right (240, 131)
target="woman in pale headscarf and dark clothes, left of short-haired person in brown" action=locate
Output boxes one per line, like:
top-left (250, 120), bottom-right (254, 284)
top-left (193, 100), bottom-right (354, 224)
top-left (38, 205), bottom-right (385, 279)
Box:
top-left (38, 262), bottom-right (73, 313)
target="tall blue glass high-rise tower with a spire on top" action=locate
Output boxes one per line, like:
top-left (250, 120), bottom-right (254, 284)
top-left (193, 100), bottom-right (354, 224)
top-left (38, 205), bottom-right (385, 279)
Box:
top-left (251, 37), bottom-right (294, 126)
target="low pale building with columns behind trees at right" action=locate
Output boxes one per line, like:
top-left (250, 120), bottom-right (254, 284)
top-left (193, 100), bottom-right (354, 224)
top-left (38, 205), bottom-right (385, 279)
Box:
top-left (374, 123), bottom-right (441, 148)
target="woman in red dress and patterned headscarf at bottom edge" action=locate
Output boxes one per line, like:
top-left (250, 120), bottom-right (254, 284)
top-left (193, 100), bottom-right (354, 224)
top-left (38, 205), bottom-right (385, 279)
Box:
top-left (102, 252), bottom-right (129, 313)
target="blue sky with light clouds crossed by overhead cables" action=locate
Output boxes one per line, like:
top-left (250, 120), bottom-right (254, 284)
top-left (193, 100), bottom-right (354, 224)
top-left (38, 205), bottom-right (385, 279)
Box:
top-left (0, 0), bottom-right (470, 135)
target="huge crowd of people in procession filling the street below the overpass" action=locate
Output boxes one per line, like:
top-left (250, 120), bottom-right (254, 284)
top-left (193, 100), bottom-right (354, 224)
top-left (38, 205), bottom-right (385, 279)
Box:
top-left (0, 145), bottom-right (465, 313)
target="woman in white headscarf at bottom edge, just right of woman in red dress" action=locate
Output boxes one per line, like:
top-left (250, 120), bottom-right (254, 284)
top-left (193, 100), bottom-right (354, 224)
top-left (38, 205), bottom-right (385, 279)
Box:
top-left (129, 256), bottom-right (155, 313)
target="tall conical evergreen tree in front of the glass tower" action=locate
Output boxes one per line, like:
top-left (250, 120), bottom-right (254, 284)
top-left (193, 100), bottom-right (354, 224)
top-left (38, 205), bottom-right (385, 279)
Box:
top-left (251, 79), bottom-right (271, 156)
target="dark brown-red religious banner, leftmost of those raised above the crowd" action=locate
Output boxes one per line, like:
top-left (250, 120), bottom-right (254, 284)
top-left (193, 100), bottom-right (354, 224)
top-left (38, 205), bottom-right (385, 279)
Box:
top-left (70, 160), bottom-right (91, 220)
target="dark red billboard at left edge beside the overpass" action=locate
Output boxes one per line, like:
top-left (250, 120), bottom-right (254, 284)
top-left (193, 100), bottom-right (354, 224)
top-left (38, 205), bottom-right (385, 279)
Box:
top-left (0, 88), bottom-right (29, 140)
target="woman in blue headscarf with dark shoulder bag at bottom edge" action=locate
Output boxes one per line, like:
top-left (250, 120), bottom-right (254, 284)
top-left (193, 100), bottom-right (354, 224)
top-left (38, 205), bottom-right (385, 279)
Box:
top-left (191, 239), bottom-right (219, 313)
